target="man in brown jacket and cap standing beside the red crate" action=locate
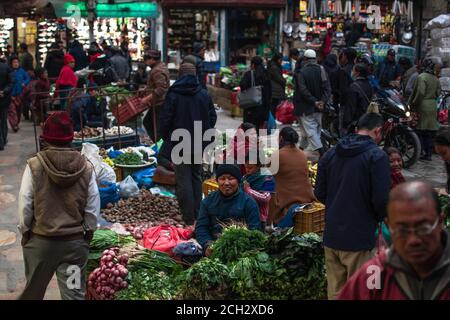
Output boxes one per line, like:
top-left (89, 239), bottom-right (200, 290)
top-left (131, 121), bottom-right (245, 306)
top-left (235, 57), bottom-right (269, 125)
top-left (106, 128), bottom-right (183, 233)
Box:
top-left (142, 50), bottom-right (170, 143)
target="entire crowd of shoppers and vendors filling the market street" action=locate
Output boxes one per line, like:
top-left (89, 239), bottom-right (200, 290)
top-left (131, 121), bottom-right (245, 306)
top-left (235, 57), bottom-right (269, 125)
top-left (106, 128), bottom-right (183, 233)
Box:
top-left (0, 30), bottom-right (450, 299)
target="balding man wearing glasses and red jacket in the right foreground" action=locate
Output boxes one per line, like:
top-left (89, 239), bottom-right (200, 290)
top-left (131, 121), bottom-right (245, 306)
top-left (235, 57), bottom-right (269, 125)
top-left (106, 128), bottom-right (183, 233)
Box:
top-left (338, 181), bottom-right (450, 300)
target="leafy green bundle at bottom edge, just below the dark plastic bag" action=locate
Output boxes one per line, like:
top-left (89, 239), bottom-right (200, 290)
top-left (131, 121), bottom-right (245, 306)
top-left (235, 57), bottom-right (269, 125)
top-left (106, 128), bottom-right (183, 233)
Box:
top-left (176, 258), bottom-right (230, 300)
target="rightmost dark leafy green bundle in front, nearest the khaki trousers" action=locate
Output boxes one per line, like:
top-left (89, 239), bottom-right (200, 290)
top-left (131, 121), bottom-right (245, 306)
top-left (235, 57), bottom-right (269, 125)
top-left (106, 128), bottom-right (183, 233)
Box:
top-left (230, 252), bottom-right (291, 300)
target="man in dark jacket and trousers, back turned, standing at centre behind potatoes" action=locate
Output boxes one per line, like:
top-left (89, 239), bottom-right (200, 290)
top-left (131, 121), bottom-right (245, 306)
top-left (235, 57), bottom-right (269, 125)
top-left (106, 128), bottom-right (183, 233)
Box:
top-left (159, 63), bottom-right (217, 225)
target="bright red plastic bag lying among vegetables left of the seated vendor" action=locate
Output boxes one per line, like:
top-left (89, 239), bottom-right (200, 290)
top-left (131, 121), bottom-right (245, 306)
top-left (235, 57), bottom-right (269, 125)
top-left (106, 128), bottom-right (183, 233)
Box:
top-left (144, 224), bottom-right (192, 256)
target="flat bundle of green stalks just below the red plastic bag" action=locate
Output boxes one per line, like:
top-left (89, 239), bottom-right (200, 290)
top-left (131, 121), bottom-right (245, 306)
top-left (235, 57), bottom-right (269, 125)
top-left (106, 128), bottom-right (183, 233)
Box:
top-left (128, 249), bottom-right (183, 275)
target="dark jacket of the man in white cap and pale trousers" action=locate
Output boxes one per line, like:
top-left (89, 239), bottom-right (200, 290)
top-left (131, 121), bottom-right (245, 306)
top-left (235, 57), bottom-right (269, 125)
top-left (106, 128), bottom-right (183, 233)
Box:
top-left (294, 61), bottom-right (331, 117)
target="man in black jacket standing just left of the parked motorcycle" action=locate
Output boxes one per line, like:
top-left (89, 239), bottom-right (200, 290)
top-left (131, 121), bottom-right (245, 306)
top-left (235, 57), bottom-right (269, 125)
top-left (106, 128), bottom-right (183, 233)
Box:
top-left (341, 63), bottom-right (373, 135)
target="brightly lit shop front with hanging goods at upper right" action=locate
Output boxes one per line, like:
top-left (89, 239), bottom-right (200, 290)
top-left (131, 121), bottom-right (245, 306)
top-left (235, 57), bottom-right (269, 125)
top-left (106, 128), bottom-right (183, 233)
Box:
top-left (283, 0), bottom-right (421, 62)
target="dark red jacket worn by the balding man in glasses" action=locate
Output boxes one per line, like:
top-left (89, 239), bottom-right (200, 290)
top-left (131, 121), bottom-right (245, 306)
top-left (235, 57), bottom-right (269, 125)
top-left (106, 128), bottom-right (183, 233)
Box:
top-left (338, 235), bottom-right (450, 300)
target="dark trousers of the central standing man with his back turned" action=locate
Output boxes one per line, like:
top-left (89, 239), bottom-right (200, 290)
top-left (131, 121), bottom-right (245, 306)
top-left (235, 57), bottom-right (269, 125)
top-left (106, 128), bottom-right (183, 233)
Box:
top-left (175, 164), bottom-right (202, 225)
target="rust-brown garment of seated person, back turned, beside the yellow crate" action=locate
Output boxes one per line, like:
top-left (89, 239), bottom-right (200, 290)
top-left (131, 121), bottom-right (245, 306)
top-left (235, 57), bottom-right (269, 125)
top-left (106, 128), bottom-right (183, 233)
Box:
top-left (268, 146), bottom-right (315, 224)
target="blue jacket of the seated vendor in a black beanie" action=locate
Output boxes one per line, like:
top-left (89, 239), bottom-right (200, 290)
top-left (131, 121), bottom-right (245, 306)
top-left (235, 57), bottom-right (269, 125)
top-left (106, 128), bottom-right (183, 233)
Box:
top-left (195, 190), bottom-right (260, 251)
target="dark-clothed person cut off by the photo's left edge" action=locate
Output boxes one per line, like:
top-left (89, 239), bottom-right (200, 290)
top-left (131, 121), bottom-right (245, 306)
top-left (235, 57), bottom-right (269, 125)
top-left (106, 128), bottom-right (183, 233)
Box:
top-left (0, 62), bottom-right (13, 150)
